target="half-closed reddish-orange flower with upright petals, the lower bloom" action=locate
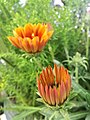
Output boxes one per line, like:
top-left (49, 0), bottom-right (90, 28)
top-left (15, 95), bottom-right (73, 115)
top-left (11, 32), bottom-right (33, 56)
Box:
top-left (37, 64), bottom-right (71, 105)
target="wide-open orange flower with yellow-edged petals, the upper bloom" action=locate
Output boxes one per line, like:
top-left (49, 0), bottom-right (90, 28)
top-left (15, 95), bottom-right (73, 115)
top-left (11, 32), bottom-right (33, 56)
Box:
top-left (8, 23), bottom-right (53, 53)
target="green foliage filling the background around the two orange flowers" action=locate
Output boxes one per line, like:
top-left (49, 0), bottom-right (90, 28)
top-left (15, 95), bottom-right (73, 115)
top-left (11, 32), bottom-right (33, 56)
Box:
top-left (0, 0), bottom-right (90, 120)
